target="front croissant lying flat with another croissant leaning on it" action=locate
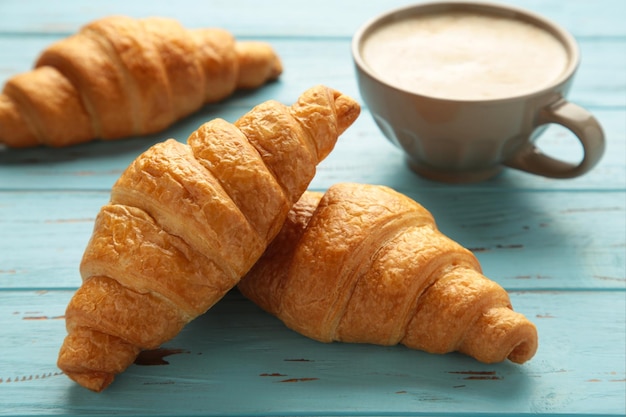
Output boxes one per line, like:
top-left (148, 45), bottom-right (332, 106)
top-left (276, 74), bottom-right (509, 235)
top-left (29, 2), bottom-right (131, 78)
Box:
top-left (238, 184), bottom-right (537, 363)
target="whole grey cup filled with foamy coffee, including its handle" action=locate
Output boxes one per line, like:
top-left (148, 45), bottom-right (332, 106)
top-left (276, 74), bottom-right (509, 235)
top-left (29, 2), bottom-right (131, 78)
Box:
top-left (353, 2), bottom-right (604, 182)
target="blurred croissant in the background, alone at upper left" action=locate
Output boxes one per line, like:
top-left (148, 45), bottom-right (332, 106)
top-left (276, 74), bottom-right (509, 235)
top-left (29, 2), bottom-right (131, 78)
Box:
top-left (0, 16), bottom-right (282, 148)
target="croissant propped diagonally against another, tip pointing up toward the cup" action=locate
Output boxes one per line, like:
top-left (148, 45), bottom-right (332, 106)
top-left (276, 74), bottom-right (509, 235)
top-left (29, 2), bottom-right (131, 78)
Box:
top-left (58, 86), bottom-right (360, 391)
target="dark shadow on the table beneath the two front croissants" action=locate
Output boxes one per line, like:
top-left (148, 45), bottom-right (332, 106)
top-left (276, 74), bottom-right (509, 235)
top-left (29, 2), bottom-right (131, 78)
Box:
top-left (65, 290), bottom-right (532, 413)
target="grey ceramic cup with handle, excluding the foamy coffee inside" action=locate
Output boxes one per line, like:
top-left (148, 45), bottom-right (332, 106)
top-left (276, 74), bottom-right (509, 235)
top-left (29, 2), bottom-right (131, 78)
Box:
top-left (352, 2), bottom-right (605, 183)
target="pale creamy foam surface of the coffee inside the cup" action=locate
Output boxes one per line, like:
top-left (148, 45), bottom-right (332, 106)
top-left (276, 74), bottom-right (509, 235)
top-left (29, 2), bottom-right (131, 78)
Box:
top-left (362, 12), bottom-right (568, 100)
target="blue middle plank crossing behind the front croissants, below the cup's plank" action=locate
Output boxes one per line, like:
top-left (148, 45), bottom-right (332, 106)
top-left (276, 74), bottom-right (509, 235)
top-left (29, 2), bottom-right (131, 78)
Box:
top-left (0, 189), bottom-right (626, 290)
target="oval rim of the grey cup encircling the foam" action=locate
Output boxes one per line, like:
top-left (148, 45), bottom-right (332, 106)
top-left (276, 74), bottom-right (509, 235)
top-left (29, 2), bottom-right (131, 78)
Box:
top-left (351, 0), bottom-right (580, 103)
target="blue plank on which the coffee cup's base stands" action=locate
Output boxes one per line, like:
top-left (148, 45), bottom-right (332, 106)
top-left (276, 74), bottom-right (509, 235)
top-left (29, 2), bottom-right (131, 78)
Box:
top-left (0, 106), bottom-right (626, 191)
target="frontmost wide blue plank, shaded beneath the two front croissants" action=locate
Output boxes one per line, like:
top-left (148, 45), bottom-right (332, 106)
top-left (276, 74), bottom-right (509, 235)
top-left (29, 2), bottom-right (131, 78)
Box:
top-left (0, 291), bottom-right (626, 416)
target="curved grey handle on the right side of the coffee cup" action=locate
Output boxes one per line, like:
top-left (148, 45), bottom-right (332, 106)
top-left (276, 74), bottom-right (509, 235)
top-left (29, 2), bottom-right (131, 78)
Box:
top-left (504, 99), bottom-right (605, 178)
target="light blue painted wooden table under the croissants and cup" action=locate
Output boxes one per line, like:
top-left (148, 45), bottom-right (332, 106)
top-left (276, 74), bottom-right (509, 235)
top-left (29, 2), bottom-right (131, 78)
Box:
top-left (0, 0), bottom-right (626, 416)
